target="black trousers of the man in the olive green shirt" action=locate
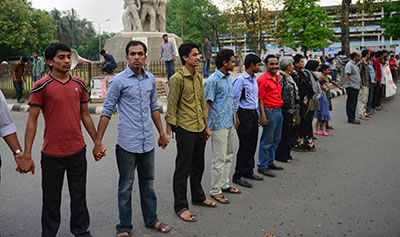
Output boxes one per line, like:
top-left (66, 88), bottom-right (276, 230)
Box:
top-left (173, 127), bottom-right (206, 212)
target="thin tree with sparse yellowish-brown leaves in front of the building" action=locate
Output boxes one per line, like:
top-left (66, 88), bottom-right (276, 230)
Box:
top-left (226, 0), bottom-right (278, 55)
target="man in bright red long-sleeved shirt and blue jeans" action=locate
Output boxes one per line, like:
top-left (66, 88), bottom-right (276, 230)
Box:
top-left (257, 55), bottom-right (283, 177)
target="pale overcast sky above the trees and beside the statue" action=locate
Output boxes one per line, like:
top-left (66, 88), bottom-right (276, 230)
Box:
top-left (31, 0), bottom-right (341, 32)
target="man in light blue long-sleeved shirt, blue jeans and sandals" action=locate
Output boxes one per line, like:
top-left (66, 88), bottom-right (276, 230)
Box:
top-left (93, 41), bottom-right (170, 236)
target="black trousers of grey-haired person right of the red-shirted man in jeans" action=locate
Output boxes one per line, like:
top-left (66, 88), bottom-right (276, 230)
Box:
top-left (276, 112), bottom-right (293, 162)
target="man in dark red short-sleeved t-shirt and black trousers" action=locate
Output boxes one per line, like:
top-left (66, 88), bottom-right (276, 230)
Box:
top-left (21, 43), bottom-right (105, 236)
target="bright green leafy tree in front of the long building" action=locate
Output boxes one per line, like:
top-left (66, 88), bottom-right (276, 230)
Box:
top-left (278, 0), bottom-right (335, 55)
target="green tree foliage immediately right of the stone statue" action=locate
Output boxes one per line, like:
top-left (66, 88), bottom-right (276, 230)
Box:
top-left (166, 0), bottom-right (227, 47)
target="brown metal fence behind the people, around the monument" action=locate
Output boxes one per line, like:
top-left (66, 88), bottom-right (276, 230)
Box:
top-left (0, 61), bottom-right (215, 99)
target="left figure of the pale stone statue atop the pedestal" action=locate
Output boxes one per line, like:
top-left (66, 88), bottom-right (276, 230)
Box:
top-left (122, 0), bottom-right (143, 32)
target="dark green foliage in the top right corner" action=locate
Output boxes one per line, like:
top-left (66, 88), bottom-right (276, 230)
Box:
top-left (380, 1), bottom-right (400, 39)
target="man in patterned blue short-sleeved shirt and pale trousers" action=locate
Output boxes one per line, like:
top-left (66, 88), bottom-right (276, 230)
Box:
top-left (204, 49), bottom-right (240, 204)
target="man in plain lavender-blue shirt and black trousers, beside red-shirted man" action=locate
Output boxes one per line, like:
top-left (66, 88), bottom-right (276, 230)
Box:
top-left (232, 54), bottom-right (263, 188)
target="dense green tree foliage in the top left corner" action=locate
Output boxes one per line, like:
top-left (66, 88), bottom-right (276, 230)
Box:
top-left (0, 0), bottom-right (55, 58)
